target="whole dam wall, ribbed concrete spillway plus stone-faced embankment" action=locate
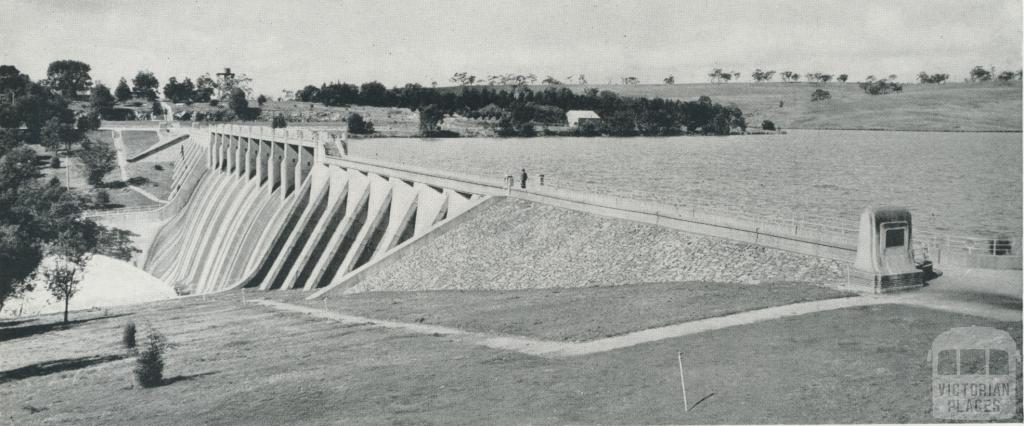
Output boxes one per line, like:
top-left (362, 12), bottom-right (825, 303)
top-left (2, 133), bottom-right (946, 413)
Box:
top-left (144, 125), bottom-right (1019, 297)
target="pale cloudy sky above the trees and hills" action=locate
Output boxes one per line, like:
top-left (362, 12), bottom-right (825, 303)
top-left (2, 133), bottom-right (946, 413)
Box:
top-left (0, 0), bottom-right (1022, 96)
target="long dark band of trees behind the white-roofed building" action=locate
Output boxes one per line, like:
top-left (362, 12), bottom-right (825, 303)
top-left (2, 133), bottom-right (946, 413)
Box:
top-left (296, 81), bottom-right (746, 136)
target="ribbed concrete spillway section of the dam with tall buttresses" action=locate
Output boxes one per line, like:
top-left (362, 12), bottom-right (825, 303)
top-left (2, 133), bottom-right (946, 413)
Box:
top-left (144, 126), bottom-right (485, 293)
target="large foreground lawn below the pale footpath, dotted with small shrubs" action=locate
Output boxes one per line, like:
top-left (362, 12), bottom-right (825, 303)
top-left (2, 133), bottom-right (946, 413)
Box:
top-left (0, 292), bottom-right (1021, 425)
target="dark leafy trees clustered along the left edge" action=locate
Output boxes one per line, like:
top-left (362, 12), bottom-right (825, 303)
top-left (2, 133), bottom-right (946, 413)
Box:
top-left (0, 61), bottom-right (137, 322)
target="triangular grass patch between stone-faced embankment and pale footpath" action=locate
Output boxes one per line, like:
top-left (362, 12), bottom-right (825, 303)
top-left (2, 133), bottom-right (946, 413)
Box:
top-left (292, 282), bottom-right (852, 341)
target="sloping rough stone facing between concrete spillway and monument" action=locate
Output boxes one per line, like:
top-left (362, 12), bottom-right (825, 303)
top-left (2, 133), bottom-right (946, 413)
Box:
top-left (348, 199), bottom-right (847, 292)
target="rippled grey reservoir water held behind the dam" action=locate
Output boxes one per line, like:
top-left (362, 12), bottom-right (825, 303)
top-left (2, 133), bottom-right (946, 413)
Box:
top-left (349, 130), bottom-right (1021, 237)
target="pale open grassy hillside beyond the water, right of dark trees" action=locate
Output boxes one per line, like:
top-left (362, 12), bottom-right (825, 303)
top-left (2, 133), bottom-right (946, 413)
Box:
top-left (565, 81), bottom-right (1021, 131)
